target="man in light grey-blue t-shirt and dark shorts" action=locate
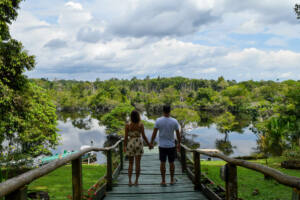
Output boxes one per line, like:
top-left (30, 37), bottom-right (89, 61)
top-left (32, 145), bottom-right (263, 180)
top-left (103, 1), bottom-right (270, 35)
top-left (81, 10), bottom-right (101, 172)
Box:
top-left (151, 105), bottom-right (181, 186)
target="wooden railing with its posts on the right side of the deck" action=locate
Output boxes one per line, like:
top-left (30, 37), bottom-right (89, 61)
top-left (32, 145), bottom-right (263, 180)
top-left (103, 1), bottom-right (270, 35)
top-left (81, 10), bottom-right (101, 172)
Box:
top-left (178, 144), bottom-right (300, 200)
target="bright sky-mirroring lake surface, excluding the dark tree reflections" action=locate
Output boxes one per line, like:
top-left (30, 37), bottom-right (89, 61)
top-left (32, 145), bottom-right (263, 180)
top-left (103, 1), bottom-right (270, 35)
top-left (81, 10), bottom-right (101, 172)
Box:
top-left (53, 116), bottom-right (257, 163)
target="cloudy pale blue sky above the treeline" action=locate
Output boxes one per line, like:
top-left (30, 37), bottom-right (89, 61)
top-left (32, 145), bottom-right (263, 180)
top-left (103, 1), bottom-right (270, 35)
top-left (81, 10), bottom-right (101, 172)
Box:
top-left (11, 0), bottom-right (300, 81)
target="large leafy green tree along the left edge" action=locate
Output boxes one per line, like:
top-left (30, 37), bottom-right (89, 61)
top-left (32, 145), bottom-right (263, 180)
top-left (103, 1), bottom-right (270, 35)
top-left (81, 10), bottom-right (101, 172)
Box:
top-left (0, 0), bottom-right (59, 166)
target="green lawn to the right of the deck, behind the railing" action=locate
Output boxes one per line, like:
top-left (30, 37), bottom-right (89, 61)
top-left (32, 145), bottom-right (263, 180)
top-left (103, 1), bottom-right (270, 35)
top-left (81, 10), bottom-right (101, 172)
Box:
top-left (201, 157), bottom-right (300, 200)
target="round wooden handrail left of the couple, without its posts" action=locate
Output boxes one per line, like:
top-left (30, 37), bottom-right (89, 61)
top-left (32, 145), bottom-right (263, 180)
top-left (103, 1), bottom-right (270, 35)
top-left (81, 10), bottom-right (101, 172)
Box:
top-left (0, 139), bottom-right (123, 197)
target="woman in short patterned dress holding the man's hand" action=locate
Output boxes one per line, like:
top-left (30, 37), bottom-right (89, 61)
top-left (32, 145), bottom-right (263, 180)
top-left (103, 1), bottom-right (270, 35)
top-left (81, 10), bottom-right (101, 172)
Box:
top-left (124, 110), bottom-right (150, 186)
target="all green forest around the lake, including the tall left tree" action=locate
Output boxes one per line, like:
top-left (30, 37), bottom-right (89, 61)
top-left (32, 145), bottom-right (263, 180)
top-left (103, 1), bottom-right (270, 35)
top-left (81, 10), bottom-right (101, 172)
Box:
top-left (0, 0), bottom-right (300, 169)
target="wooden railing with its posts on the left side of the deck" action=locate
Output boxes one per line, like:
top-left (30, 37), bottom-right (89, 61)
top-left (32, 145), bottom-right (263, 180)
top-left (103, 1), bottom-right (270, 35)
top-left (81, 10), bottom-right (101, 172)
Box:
top-left (0, 139), bottom-right (123, 200)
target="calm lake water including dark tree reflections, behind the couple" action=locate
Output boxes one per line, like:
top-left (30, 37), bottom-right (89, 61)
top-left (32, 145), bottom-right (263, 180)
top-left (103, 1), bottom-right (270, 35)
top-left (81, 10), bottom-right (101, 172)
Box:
top-left (52, 113), bottom-right (257, 163)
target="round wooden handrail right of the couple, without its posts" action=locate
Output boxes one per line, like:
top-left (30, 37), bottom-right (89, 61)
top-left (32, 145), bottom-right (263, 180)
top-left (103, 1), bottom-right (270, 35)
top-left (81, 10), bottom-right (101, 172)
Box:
top-left (181, 144), bottom-right (300, 189)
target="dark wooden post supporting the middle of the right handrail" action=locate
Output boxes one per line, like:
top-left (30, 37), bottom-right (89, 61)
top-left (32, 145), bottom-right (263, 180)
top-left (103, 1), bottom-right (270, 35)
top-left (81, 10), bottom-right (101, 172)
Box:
top-left (225, 163), bottom-right (238, 200)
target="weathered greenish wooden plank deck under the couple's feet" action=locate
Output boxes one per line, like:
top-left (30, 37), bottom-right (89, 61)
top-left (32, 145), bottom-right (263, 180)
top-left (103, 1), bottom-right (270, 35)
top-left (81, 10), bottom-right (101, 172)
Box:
top-left (105, 148), bottom-right (207, 200)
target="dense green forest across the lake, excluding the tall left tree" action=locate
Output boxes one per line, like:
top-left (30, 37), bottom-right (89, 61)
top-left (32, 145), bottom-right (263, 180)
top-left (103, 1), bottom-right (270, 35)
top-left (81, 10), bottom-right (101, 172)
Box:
top-left (31, 77), bottom-right (300, 159)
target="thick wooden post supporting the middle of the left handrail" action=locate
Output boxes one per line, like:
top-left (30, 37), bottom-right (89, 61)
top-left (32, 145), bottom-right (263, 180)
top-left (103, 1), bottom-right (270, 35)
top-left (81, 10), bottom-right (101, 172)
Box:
top-left (72, 157), bottom-right (83, 200)
